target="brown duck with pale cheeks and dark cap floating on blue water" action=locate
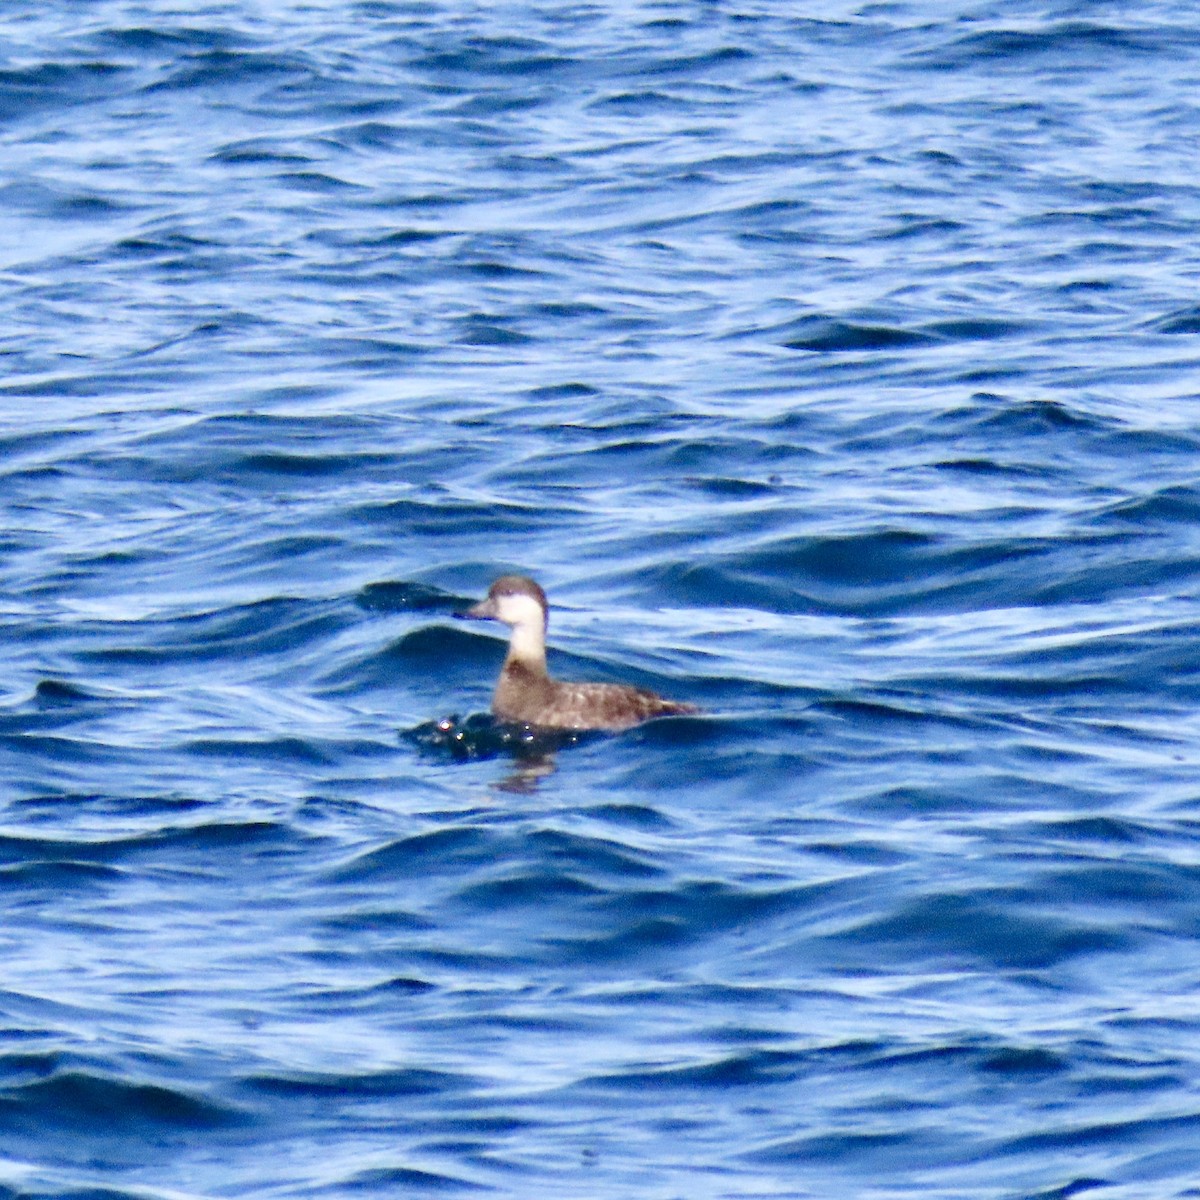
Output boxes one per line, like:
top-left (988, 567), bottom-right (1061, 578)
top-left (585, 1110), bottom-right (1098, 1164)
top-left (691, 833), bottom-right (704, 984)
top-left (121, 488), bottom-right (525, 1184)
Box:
top-left (455, 575), bottom-right (700, 733)
